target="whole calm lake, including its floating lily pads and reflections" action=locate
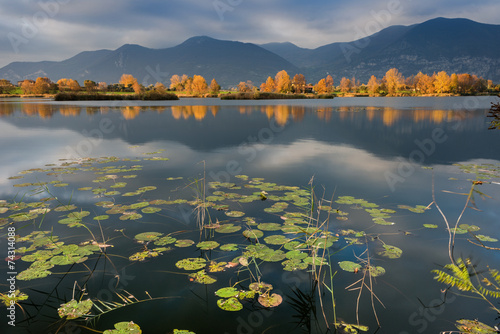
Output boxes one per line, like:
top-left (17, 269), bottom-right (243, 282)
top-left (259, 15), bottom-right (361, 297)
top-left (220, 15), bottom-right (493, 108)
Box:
top-left (0, 97), bottom-right (500, 334)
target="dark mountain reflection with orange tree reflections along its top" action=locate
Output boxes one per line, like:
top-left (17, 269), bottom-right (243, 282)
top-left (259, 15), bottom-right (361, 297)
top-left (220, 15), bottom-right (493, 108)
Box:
top-left (0, 103), bottom-right (500, 164)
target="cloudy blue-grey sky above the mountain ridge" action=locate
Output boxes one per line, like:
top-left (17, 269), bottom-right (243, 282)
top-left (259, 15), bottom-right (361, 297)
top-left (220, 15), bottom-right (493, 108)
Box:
top-left (0, 0), bottom-right (500, 67)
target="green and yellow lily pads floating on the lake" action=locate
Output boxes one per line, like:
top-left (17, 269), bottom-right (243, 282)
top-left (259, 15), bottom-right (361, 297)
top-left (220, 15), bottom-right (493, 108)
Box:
top-left (0, 155), bottom-right (500, 333)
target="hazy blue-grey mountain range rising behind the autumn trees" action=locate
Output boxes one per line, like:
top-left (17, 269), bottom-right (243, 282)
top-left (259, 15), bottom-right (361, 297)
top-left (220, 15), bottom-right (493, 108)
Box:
top-left (0, 18), bottom-right (500, 87)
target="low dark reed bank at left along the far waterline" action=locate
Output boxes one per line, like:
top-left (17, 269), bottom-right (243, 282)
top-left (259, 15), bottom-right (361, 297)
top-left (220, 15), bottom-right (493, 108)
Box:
top-left (54, 91), bottom-right (179, 101)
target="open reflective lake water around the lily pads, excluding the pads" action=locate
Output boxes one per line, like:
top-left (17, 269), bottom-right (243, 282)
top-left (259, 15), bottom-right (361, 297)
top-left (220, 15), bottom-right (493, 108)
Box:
top-left (0, 97), bottom-right (500, 333)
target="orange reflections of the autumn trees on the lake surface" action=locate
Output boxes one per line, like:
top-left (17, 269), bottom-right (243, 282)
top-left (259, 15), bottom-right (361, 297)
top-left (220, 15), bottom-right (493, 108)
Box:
top-left (0, 103), bottom-right (472, 127)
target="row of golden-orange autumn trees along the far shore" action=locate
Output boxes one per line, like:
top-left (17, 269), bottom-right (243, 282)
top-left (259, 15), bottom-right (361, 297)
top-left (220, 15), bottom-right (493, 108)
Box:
top-left (0, 68), bottom-right (500, 100)
